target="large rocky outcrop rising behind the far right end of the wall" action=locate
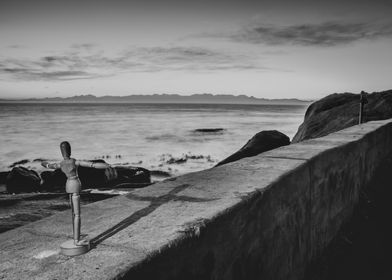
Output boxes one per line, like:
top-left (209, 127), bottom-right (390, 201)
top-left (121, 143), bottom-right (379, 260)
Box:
top-left (292, 90), bottom-right (392, 143)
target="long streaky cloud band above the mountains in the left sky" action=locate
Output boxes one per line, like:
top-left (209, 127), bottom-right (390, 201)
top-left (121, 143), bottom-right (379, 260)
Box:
top-left (0, 44), bottom-right (267, 81)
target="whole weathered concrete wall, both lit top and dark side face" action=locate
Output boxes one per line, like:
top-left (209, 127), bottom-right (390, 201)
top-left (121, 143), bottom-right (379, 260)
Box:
top-left (0, 120), bottom-right (392, 279)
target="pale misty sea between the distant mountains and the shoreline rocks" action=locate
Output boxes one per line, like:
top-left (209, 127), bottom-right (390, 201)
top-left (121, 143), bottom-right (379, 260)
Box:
top-left (0, 103), bottom-right (308, 180)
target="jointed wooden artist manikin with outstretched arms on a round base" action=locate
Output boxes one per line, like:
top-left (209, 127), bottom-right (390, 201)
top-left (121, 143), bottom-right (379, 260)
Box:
top-left (42, 141), bottom-right (110, 256)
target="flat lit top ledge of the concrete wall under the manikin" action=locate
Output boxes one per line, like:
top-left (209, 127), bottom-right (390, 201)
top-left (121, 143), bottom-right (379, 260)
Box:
top-left (0, 120), bottom-right (392, 279)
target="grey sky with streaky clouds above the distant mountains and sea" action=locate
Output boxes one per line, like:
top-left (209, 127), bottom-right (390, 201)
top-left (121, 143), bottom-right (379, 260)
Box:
top-left (0, 0), bottom-right (392, 99)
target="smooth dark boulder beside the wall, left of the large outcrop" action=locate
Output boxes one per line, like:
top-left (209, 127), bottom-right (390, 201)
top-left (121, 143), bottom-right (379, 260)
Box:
top-left (216, 130), bottom-right (290, 166)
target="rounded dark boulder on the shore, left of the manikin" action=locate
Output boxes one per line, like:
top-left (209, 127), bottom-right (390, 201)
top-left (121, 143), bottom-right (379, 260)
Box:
top-left (6, 166), bottom-right (41, 193)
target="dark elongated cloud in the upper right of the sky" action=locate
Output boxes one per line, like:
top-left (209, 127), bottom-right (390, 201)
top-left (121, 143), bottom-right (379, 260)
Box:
top-left (227, 22), bottom-right (392, 47)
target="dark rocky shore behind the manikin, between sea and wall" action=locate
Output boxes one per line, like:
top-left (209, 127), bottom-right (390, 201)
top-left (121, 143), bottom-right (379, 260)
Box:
top-left (0, 160), bottom-right (151, 233)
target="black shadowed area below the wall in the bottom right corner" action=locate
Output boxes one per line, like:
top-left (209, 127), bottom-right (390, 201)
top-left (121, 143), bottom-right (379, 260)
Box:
top-left (303, 153), bottom-right (392, 280)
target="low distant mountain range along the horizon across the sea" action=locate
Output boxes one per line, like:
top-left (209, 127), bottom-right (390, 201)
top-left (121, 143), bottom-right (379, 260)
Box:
top-left (0, 93), bottom-right (311, 104)
